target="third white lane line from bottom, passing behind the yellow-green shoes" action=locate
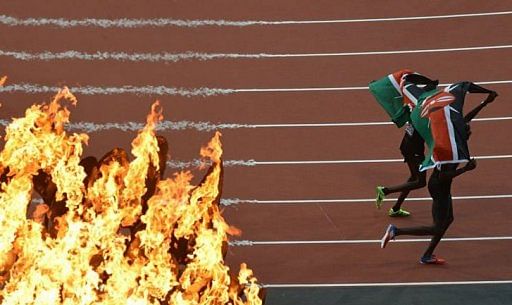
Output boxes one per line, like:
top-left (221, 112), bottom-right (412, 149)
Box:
top-left (221, 194), bottom-right (512, 206)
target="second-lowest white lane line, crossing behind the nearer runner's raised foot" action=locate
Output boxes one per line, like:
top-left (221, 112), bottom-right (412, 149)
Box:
top-left (229, 236), bottom-right (512, 247)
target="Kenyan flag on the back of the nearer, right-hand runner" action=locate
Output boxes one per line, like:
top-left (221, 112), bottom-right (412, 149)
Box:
top-left (411, 85), bottom-right (470, 171)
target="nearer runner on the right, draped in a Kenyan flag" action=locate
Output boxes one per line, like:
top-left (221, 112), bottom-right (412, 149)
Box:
top-left (381, 82), bottom-right (498, 264)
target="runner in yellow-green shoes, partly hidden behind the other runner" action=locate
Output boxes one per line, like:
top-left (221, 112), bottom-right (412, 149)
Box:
top-left (375, 70), bottom-right (439, 217)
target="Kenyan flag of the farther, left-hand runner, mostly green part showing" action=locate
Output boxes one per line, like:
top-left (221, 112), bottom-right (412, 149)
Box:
top-left (369, 70), bottom-right (412, 127)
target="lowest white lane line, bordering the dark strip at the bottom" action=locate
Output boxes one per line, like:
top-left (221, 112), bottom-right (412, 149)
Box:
top-left (262, 280), bottom-right (512, 288)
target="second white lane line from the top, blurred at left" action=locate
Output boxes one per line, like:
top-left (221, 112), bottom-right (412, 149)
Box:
top-left (0, 45), bottom-right (512, 62)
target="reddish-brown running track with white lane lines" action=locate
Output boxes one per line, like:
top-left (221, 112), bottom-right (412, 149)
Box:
top-left (0, 0), bottom-right (512, 304)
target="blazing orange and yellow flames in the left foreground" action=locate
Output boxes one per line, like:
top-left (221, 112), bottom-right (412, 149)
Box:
top-left (0, 86), bottom-right (263, 305)
